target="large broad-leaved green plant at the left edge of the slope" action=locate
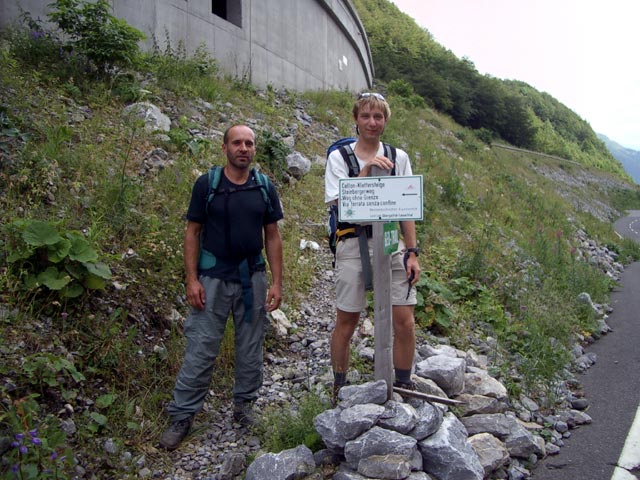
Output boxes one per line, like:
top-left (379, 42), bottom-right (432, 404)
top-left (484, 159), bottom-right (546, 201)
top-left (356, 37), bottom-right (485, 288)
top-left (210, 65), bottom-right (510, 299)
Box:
top-left (3, 219), bottom-right (111, 298)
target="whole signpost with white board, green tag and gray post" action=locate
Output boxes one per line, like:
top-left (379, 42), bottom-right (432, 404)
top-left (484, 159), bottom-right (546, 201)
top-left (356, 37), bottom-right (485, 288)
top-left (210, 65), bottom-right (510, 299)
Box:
top-left (338, 171), bottom-right (423, 399)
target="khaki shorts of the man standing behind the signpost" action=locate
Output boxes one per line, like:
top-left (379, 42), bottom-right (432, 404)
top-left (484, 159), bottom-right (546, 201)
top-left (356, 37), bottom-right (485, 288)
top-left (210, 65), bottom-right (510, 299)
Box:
top-left (336, 238), bottom-right (417, 312)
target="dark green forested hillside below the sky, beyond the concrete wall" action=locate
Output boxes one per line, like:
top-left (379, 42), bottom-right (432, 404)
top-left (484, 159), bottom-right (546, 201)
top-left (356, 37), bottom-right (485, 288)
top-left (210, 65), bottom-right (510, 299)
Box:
top-left (354, 0), bottom-right (626, 176)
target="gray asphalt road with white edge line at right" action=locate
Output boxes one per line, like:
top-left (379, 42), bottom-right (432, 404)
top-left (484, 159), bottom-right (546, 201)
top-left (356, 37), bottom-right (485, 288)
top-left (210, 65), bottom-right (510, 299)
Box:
top-left (532, 215), bottom-right (640, 480)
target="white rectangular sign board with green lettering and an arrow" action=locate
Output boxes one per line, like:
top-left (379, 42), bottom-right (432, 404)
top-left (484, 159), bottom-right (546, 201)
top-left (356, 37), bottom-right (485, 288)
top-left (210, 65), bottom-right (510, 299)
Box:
top-left (338, 175), bottom-right (423, 222)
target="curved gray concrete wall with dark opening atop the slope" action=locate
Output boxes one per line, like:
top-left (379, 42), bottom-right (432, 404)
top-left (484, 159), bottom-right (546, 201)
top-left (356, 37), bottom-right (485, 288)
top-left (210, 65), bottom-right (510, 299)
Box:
top-left (0, 0), bottom-right (373, 91)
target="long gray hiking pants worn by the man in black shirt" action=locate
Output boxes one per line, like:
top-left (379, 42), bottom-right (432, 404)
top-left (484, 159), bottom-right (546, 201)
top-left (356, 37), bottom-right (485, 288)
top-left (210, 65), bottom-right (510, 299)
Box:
top-left (167, 272), bottom-right (267, 421)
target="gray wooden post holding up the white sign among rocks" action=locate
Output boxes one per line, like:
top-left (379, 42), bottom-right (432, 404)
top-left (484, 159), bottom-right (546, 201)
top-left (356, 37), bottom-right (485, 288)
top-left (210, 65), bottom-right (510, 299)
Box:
top-left (371, 167), bottom-right (394, 400)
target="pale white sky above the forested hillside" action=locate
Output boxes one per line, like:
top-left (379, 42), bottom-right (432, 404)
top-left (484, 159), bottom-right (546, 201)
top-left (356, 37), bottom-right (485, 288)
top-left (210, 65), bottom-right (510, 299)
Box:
top-left (391, 0), bottom-right (640, 150)
